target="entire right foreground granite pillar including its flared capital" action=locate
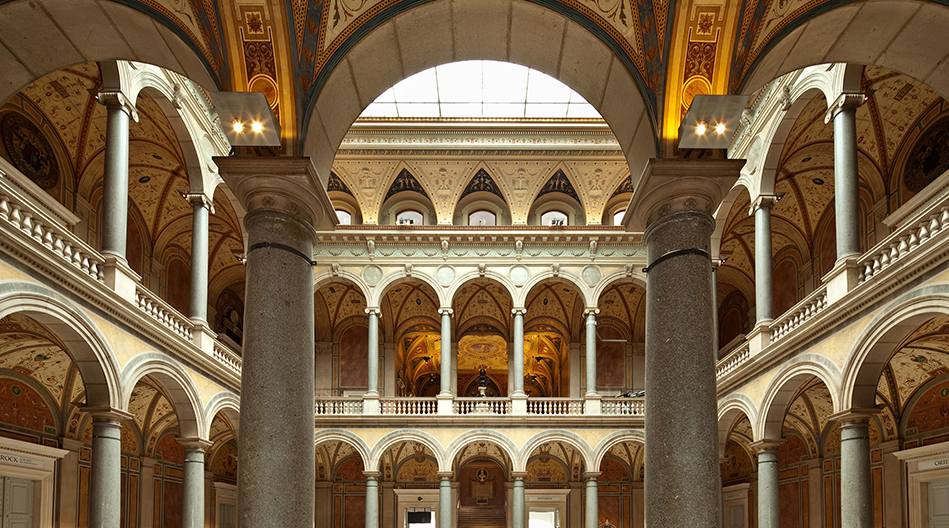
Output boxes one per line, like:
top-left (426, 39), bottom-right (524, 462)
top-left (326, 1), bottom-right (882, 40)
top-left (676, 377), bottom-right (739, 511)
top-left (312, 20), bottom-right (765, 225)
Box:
top-left (627, 159), bottom-right (744, 528)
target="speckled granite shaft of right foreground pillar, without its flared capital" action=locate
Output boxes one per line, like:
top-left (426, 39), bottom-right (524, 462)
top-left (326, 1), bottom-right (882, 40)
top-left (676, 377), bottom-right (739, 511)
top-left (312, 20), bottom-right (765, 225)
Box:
top-left (644, 210), bottom-right (721, 528)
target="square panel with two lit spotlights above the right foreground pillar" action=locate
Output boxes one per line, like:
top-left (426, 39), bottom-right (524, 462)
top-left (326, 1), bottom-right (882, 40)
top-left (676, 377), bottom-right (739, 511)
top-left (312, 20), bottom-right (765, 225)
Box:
top-left (679, 95), bottom-right (748, 149)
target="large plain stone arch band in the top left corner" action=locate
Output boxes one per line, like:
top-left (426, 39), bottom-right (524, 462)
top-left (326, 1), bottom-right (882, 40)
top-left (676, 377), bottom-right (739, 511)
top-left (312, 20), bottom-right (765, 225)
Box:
top-left (0, 0), bottom-right (218, 106)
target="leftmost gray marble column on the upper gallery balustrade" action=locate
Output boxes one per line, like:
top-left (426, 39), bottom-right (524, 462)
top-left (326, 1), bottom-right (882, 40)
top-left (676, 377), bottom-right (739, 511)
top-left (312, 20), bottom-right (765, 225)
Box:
top-left (102, 99), bottom-right (129, 260)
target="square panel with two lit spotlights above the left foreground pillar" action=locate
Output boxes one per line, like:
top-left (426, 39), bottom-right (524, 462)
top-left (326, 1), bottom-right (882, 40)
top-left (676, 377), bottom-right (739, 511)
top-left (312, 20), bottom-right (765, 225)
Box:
top-left (211, 92), bottom-right (280, 147)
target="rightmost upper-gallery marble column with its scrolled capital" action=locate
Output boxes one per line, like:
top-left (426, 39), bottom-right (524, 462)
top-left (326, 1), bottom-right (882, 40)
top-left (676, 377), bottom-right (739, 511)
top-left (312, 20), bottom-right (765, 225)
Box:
top-left (824, 93), bottom-right (866, 262)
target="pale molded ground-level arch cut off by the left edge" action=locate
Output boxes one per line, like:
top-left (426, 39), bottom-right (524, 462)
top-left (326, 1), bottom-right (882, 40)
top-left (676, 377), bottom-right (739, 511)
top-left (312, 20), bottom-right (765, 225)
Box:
top-left (0, 280), bottom-right (126, 409)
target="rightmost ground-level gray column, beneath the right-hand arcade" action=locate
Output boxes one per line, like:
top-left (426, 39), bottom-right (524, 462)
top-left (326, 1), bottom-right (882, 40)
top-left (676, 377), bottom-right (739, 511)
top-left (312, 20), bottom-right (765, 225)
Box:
top-left (840, 419), bottom-right (874, 528)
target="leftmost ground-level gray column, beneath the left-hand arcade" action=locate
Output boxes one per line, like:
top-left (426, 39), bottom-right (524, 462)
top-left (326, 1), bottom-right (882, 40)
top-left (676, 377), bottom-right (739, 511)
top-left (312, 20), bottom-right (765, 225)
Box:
top-left (89, 416), bottom-right (122, 528)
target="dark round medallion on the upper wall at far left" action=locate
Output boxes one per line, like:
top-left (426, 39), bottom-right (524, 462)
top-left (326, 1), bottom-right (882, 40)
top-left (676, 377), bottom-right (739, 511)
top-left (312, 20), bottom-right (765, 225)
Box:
top-left (0, 114), bottom-right (59, 189)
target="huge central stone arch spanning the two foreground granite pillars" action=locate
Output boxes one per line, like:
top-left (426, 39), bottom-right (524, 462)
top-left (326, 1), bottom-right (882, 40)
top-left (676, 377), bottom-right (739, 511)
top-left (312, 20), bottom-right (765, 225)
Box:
top-left (302, 0), bottom-right (658, 188)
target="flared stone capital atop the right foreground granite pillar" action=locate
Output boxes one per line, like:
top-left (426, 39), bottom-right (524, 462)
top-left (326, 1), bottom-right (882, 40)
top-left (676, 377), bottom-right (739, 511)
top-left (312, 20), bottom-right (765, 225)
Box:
top-left (624, 158), bottom-right (745, 232)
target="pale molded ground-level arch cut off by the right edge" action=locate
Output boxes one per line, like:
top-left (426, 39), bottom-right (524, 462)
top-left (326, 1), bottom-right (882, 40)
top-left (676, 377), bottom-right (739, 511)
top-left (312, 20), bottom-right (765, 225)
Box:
top-left (840, 283), bottom-right (949, 409)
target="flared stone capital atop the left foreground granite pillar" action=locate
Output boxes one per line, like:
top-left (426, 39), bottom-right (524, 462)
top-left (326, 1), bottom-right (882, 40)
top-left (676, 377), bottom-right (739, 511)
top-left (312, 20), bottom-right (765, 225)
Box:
top-left (214, 157), bottom-right (338, 230)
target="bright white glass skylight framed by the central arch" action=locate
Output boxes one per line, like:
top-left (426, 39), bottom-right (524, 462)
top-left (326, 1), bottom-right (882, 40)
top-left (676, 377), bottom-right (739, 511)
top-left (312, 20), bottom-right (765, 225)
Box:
top-left (360, 61), bottom-right (600, 119)
